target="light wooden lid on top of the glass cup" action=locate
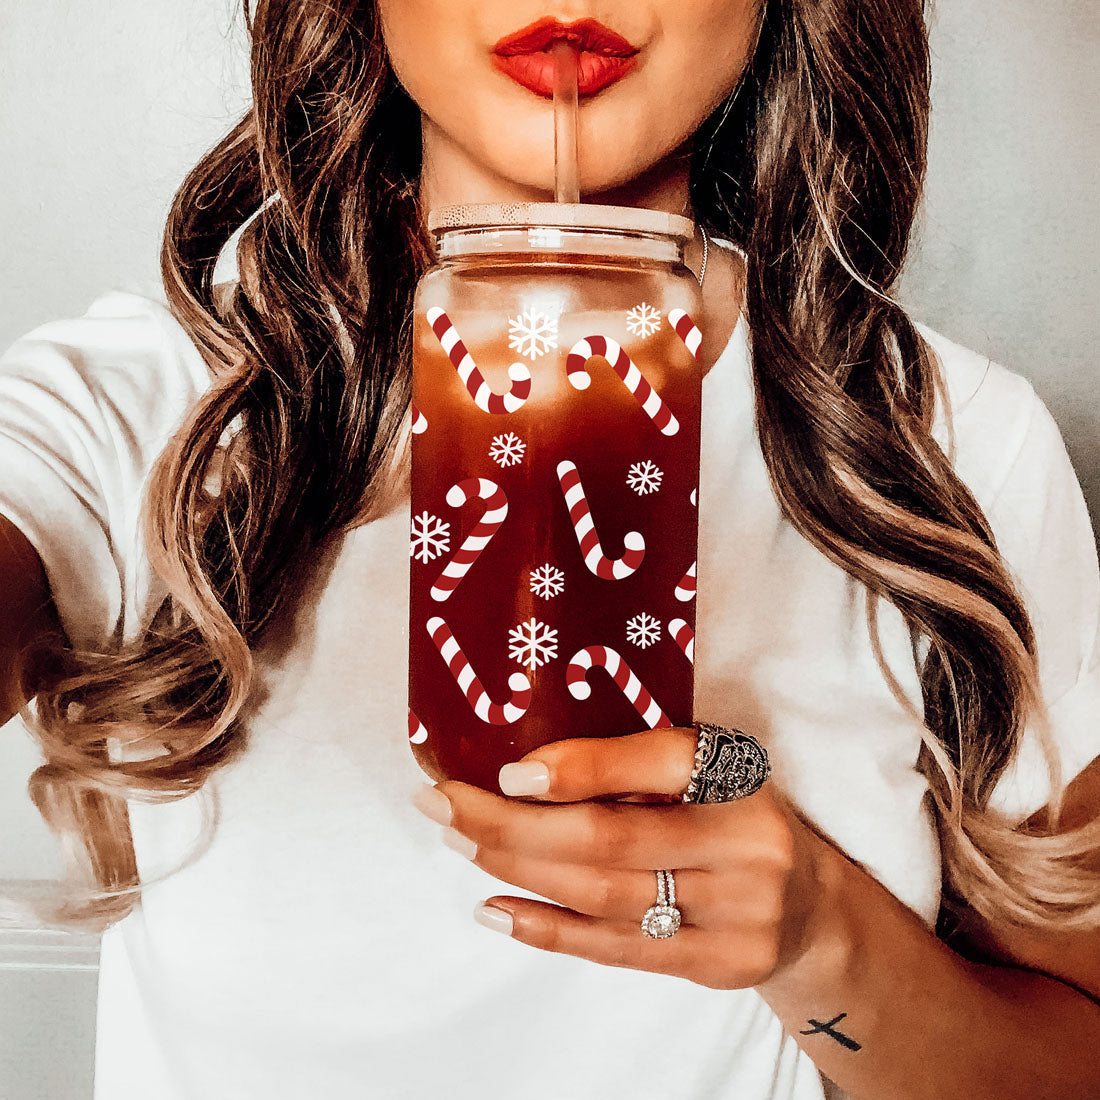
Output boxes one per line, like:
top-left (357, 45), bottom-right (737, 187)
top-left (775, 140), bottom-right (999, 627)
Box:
top-left (428, 202), bottom-right (695, 243)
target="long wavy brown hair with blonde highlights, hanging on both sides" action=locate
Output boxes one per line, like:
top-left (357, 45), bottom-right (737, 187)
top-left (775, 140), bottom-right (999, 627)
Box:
top-left (17, 0), bottom-right (1100, 930)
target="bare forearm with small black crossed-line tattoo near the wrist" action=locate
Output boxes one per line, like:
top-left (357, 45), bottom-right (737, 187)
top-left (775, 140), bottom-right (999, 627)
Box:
top-left (760, 759), bottom-right (1100, 1100)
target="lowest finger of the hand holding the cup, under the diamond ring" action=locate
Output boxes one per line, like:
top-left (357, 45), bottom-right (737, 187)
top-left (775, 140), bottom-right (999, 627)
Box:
top-left (485, 897), bottom-right (772, 989)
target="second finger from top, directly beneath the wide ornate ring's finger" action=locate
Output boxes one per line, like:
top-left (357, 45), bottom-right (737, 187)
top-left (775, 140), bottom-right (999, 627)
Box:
top-left (437, 780), bottom-right (766, 870)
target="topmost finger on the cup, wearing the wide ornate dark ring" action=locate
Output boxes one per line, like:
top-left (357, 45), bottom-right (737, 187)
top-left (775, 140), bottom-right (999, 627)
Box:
top-left (498, 726), bottom-right (699, 802)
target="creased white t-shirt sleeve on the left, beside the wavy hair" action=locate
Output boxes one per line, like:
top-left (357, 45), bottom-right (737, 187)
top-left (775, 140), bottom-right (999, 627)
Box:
top-left (0, 292), bottom-right (208, 649)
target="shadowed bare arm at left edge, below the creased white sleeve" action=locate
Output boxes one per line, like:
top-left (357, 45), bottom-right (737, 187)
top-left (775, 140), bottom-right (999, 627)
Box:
top-left (0, 516), bottom-right (61, 724)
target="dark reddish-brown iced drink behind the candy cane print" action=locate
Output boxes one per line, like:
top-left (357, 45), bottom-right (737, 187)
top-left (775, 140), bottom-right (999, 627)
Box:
top-left (409, 262), bottom-right (701, 791)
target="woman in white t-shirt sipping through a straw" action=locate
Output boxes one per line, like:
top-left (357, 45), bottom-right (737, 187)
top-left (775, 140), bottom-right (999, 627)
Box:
top-left (0, 0), bottom-right (1100, 1100)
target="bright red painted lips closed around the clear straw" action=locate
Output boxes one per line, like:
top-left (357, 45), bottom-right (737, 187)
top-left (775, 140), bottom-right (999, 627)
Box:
top-left (493, 18), bottom-right (638, 99)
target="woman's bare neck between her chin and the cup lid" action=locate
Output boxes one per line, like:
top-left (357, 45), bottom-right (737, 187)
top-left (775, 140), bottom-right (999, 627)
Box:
top-left (420, 118), bottom-right (703, 271)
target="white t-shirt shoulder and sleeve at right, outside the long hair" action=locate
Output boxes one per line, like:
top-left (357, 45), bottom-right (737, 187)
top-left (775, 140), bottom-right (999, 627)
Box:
top-left (921, 326), bottom-right (1100, 822)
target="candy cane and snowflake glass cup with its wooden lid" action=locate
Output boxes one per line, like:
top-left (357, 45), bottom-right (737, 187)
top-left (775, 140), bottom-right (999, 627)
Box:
top-left (409, 204), bottom-right (702, 791)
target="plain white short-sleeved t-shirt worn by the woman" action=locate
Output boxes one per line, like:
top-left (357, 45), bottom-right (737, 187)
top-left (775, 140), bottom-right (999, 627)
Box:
top-left (0, 266), bottom-right (1100, 1100)
